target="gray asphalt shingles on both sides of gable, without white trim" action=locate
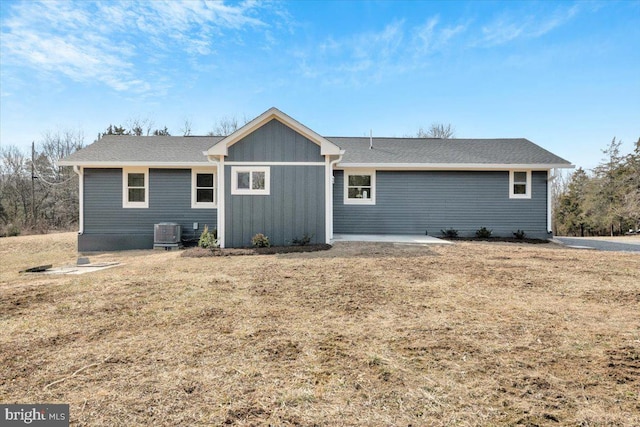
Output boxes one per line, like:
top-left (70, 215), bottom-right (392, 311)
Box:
top-left (61, 135), bottom-right (570, 166)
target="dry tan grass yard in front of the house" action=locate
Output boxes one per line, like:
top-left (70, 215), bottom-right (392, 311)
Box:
top-left (0, 233), bottom-right (640, 426)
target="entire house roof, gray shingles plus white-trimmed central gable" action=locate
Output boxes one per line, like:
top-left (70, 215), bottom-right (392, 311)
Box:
top-left (59, 108), bottom-right (573, 170)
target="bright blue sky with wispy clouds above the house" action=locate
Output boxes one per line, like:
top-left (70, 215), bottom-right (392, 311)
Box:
top-left (0, 0), bottom-right (640, 168)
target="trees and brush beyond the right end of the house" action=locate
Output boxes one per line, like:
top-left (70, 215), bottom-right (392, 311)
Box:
top-left (554, 138), bottom-right (640, 236)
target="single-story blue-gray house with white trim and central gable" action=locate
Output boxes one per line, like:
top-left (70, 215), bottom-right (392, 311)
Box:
top-left (59, 108), bottom-right (572, 252)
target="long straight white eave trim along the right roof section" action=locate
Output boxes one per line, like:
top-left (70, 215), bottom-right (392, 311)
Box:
top-left (336, 163), bottom-right (575, 170)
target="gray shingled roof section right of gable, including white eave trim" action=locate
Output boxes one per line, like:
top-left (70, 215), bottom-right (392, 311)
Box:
top-left (327, 137), bottom-right (572, 169)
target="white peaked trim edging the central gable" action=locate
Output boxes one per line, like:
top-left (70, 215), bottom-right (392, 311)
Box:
top-left (207, 107), bottom-right (340, 156)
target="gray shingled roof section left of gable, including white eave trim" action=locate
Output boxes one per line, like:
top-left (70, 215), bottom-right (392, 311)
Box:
top-left (58, 135), bottom-right (223, 167)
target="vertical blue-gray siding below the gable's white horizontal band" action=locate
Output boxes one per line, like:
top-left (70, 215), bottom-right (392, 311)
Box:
top-left (225, 165), bottom-right (325, 247)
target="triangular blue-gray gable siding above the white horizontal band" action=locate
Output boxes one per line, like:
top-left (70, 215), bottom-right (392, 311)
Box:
top-left (225, 119), bottom-right (324, 162)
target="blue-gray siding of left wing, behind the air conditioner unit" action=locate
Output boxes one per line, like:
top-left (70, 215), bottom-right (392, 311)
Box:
top-left (78, 168), bottom-right (216, 252)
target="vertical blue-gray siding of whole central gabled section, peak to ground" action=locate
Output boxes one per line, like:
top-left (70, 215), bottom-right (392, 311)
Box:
top-left (224, 119), bottom-right (326, 247)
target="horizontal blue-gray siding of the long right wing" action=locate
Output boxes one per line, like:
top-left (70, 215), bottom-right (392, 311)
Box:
top-left (333, 171), bottom-right (548, 237)
